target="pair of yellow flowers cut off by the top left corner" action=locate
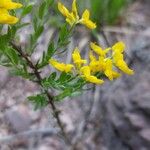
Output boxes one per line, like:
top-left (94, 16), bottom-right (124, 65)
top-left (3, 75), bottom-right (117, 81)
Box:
top-left (0, 0), bottom-right (22, 24)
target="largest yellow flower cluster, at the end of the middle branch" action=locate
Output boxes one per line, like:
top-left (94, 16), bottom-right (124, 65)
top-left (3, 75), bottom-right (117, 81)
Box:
top-left (49, 42), bottom-right (134, 84)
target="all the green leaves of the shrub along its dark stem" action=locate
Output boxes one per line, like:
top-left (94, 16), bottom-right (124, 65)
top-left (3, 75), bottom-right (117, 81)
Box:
top-left (0, 0), bottom-right (81, 109)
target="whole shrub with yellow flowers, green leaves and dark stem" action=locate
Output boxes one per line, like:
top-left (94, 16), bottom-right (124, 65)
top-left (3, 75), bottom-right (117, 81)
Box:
top-left (0, 0), bottom-right (134, 145)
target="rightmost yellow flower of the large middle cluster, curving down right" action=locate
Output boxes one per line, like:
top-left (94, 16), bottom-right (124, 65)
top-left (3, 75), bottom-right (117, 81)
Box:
top-left (112, 42), bottom-right (134, 75)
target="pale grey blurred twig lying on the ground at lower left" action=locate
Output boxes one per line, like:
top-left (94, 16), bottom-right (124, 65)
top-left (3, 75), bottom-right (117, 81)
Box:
top-left (0, 128), bottom-right (58, 144)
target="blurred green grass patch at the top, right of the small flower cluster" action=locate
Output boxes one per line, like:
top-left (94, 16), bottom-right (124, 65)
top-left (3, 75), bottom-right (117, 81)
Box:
top-left (78, 0), bottom-right (131, 27)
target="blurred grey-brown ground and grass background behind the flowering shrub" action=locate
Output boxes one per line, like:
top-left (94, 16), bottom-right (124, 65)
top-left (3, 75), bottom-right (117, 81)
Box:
top-left (0, 0), bottom-right (150, 150)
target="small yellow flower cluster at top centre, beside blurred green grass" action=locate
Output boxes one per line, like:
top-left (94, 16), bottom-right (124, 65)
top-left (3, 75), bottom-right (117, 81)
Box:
top-left (58, 0), bottom-right (96, 29)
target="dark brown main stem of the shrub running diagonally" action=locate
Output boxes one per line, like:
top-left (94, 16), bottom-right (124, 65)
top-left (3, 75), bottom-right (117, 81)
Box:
top-left (10, 42), bottom-right (71, 144)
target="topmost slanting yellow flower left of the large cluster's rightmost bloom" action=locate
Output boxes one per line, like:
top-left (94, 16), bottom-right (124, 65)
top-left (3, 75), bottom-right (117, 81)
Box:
top-left (90, 42), bottom-right (111, 57)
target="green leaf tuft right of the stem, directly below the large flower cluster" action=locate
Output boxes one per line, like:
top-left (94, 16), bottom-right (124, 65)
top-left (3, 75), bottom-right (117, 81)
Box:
top-left (42, 72), bottom-right (86, 101)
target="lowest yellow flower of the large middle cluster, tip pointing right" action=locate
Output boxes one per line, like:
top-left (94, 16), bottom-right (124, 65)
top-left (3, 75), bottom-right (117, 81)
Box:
top-left (80, 66), bottom-right (104, 84)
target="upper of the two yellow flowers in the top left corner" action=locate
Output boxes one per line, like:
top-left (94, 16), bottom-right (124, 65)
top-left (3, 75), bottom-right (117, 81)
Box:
top-left (0, 0), bottom-right (22, 10)
